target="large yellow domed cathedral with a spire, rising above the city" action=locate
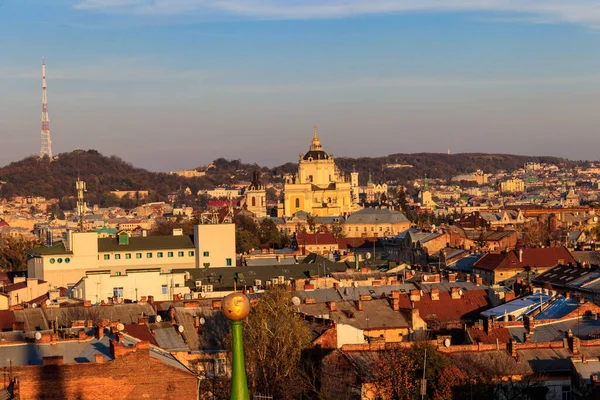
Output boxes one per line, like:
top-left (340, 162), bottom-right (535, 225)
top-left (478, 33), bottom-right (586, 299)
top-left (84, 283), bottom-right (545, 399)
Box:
top-left (277, 126), bottom-right (360, 217)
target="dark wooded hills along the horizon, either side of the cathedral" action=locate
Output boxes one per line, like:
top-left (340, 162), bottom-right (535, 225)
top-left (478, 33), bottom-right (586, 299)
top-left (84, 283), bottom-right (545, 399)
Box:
top-left (0, 150), bottom-right (585, 204)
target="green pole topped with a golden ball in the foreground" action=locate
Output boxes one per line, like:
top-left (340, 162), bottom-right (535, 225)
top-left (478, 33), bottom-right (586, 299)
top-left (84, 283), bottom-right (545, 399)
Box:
top-left (221, 292), bottom-right (250, 400)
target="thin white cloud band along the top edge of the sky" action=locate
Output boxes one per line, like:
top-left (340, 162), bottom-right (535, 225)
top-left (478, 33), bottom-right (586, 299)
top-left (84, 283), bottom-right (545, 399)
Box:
top-left (75, 0), bottom-right (600, 28)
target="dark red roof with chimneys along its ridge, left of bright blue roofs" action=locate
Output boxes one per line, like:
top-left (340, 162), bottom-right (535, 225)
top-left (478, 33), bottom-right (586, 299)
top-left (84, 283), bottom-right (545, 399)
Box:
top-left (400, 290), bottom-right (491, 323)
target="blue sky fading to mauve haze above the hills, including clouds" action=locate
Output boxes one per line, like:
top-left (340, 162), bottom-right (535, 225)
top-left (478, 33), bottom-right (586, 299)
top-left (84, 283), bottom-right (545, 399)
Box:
top-left (0, 0), bottom-right (600, 171)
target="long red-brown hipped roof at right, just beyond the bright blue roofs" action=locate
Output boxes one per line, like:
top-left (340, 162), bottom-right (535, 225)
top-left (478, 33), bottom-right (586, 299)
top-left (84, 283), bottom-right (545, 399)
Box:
top-left (473, 247), bottom-right (576, 271)
